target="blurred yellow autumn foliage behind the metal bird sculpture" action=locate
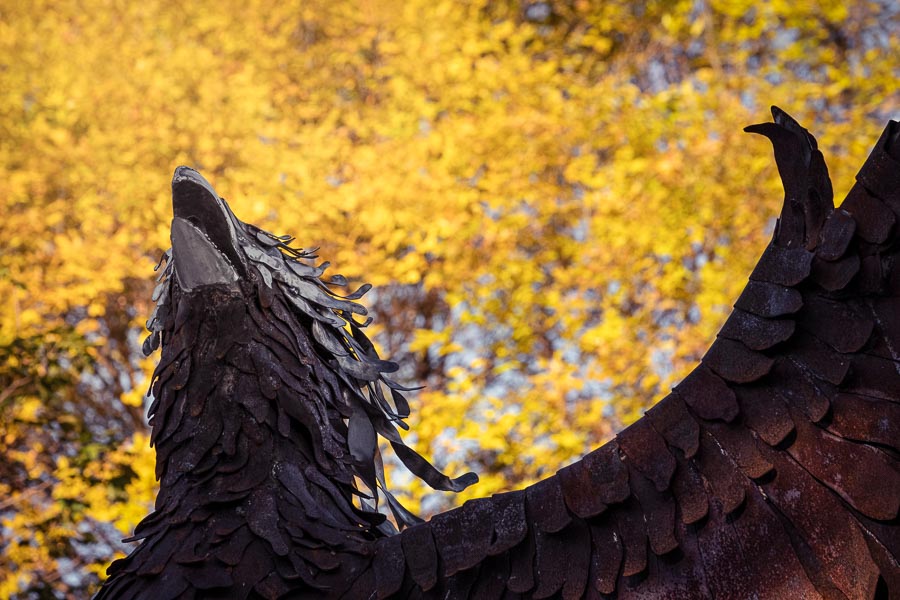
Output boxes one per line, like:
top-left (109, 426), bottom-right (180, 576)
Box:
top-left (0, 0), bottom-right (900, 598)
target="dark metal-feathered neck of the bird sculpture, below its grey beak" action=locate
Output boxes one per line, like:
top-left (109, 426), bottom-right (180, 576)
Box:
top-left (136, 289), bottom-right (377, 560)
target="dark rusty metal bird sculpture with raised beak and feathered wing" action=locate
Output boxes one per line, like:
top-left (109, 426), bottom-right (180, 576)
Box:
top-left (97, 108), bottom-right (900, 599)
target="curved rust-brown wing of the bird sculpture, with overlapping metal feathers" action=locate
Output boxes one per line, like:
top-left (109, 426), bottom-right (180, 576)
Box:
top-left (356, 108), bottom-right (900, 599)
